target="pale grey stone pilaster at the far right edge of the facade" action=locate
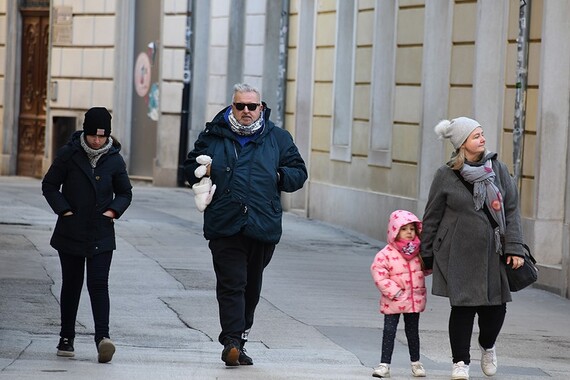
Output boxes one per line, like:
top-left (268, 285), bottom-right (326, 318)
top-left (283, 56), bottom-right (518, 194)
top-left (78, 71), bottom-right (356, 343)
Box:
top-left (531, 1), bottom-right (570, 276)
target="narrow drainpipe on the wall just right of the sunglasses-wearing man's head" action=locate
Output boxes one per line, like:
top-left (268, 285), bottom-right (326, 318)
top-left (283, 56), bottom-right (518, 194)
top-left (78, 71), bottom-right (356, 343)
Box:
top-left (275, 0), bottom-right (289, 128)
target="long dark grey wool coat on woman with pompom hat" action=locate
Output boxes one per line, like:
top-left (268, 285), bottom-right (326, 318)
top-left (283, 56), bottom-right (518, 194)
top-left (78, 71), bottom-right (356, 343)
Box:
top-left (421, 154), bottom-right (523, 306)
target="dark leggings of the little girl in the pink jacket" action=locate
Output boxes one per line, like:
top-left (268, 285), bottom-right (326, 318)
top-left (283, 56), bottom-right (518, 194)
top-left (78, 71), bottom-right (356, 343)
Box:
top-left (381, 313), bottom-right (420, 364)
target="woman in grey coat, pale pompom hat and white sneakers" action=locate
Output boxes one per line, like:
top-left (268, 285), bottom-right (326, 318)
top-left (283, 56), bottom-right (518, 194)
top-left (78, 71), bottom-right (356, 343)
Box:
top-left (421, 117), bottom-right (524, 379)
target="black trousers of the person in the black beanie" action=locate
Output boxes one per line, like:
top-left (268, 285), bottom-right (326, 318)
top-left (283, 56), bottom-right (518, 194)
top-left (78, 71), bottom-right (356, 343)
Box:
top-left (58, 251), bottom-right (113, 342)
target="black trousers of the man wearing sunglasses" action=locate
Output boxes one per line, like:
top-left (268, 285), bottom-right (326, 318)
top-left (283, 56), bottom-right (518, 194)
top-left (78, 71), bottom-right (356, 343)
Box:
top-left (209, 234), bottom-right (275, 344)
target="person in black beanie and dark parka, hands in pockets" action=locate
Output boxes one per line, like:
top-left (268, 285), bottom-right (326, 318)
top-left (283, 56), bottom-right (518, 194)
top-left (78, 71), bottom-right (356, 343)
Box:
top-left (42, 107), bottom-right (132, 363)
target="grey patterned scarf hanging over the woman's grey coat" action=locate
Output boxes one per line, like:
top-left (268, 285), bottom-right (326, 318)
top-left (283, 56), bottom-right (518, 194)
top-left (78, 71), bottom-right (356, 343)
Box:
top-left (460, 159), bottom-right (506, 235)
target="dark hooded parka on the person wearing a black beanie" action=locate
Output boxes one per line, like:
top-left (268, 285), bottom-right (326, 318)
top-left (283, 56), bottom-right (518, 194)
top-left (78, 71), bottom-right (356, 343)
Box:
top-left (42, 131), bottom-right (132, 257)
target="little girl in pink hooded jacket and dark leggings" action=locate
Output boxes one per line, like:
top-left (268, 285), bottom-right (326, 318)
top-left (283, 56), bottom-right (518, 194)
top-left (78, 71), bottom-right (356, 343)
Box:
top-left (370, 210), bottom-right (428, 377)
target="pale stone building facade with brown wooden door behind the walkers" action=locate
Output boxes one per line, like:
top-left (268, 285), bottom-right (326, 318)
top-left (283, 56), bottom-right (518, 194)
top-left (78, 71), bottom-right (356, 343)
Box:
top-left (0, 0), bottom-right (570, 297)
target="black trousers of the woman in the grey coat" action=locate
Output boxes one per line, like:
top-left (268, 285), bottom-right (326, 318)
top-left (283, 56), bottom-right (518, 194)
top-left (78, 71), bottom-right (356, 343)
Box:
top-left (449, 304), bottom-right (507, 364)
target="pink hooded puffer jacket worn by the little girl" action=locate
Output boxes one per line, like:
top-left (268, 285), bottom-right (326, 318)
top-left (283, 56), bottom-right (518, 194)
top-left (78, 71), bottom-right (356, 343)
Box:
top-left (370, 210), bottom-right (429, 314)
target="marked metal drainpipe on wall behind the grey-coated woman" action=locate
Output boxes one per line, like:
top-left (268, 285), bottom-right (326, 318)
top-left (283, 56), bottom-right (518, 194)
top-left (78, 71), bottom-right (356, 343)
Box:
top-left (513, 0), bottom-right (532, 186)
